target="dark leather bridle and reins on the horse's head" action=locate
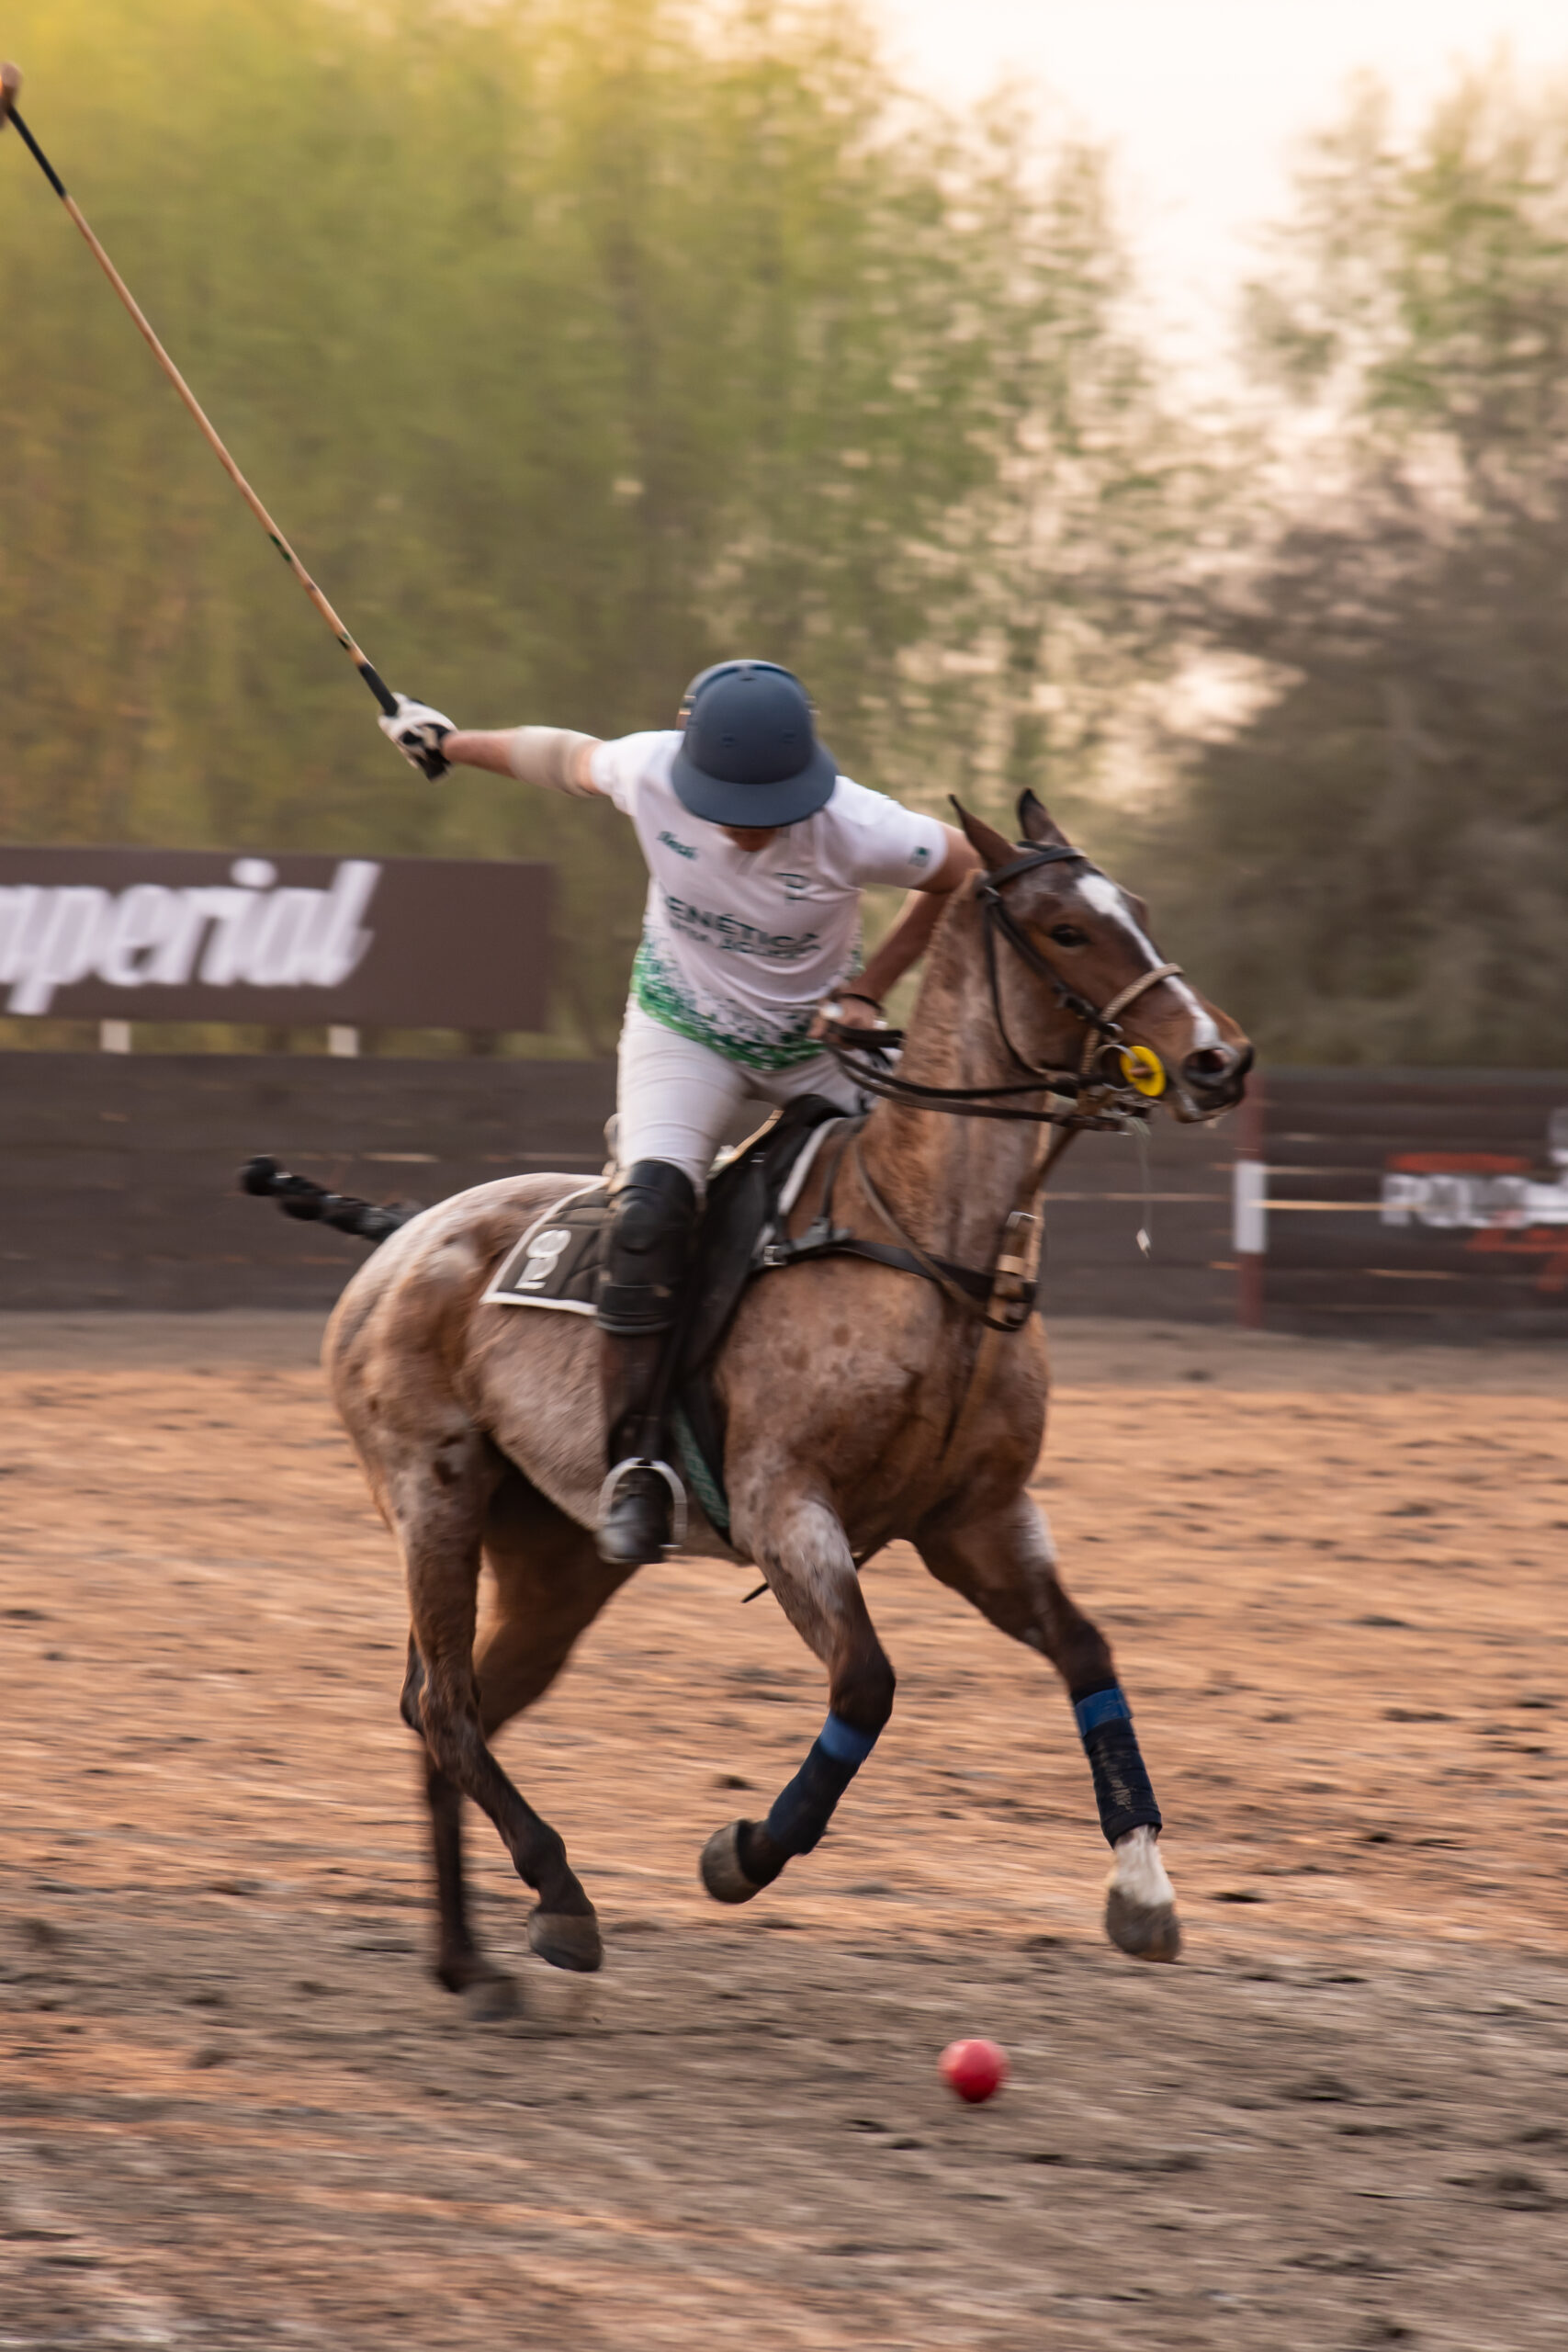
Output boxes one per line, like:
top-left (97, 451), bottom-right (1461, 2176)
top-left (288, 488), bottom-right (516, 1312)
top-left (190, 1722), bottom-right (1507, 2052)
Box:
top-left (823, 842), bottom-right (1182, 1131)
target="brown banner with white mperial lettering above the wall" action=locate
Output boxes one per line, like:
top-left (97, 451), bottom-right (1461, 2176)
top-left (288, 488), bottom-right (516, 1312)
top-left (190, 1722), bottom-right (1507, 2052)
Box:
top-left (0, 849), bottom-right (552, 1030)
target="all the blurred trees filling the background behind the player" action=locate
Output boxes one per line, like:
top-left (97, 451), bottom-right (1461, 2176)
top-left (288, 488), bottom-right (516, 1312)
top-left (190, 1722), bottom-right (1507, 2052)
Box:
top-left (0, 0), bottom-right (1568, 1063)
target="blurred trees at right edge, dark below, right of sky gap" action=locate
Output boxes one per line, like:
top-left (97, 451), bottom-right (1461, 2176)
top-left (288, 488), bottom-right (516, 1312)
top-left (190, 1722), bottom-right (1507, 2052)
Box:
top-left (1161, 62), bottom-right (1568, 1066)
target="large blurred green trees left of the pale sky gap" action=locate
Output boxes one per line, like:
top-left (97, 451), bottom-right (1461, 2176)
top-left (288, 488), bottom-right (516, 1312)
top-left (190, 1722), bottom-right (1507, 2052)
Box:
top-left (0, 0), bottom-right (1180, 1042)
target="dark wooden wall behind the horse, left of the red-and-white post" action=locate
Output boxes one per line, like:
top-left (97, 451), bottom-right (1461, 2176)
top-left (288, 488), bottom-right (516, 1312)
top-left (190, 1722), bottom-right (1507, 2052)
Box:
top-left (0, 1054), bottom-right (1236, 1322)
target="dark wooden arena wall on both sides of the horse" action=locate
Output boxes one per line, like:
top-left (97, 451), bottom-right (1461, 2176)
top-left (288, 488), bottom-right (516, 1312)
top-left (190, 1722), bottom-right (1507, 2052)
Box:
top-left (0, 1054), bottom-right (1568, 1339)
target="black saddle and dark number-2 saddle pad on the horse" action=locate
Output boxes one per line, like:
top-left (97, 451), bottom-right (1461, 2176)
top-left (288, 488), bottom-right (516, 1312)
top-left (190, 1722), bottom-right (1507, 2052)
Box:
top-left (484, 1093), bottom-right (861, 1536)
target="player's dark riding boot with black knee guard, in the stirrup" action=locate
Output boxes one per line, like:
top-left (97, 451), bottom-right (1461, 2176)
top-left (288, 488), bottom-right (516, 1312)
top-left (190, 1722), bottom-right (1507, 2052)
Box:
top-left (597, 1159), bottom-right (698, 1569)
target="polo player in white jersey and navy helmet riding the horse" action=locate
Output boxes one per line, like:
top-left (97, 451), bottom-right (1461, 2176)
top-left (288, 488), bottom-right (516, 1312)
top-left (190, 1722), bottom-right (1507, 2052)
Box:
top-left (381, 661), bottom-right (978, 1566)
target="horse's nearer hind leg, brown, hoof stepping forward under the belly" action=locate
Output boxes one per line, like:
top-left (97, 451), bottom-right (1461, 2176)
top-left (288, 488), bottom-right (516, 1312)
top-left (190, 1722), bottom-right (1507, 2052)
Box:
top-left (388, 1432), bottom-right (604, 1969)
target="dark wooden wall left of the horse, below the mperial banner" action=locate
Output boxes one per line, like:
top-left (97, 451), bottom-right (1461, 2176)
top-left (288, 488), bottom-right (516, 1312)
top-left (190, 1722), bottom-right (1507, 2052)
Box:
top-left (0, 1054), bottom-right (616, 1307)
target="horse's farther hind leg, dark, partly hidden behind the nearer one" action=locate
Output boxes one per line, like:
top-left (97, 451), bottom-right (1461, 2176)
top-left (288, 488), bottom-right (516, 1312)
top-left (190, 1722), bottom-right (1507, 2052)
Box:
top-left (402, 1470), bottom-right (632, 2008)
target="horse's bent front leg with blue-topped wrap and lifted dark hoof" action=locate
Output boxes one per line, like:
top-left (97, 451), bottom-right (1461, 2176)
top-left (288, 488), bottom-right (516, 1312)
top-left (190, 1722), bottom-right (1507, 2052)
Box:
top-left (703, 1496), bottom-right (894, 1903)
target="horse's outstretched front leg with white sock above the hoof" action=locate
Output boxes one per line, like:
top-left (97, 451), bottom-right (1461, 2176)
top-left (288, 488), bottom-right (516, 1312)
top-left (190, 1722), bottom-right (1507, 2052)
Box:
top-left (919, 1494), bottom-right (1182, 1959)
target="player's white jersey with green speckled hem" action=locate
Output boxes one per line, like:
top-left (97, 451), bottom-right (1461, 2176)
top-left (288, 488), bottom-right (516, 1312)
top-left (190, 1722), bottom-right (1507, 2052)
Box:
top-left (592, 729), bottom-right (945, 1070)
